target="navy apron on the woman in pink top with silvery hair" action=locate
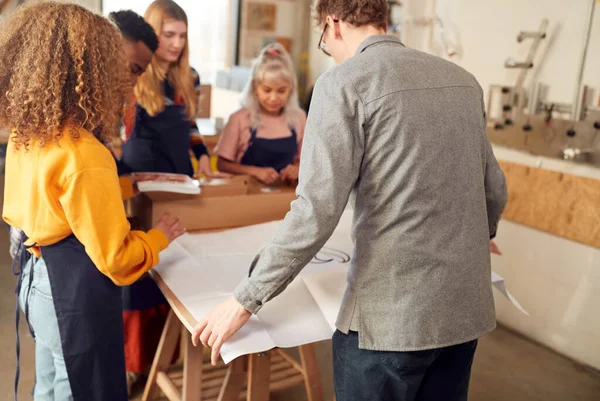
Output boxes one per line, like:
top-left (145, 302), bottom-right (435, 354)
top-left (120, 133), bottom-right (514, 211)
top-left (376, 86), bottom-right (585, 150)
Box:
top-left (240, 127), bottom-right (298, 172)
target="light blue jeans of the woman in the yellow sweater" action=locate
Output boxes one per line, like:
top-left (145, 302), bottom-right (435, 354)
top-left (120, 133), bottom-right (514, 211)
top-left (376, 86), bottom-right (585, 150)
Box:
top-left (19, 258), bottom-right (73, 401)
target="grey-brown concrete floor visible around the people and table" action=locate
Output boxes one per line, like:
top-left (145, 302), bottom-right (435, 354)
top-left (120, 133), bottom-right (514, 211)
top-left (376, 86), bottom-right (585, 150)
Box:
top-left (0, 229), bottom-right (600, 401)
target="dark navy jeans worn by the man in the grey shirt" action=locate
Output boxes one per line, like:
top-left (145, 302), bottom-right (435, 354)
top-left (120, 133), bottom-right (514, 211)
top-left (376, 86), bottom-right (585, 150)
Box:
top-left (333, 331), bottom-right (477, 401)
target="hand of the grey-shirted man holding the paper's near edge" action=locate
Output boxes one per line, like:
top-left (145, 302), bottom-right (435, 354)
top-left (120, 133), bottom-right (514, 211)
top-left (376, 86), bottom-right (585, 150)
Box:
top-left (192, 297), bottom-right (252, 365)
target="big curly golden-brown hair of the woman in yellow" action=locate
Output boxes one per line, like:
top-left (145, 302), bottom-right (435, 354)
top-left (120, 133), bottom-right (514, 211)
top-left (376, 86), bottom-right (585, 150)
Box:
top-left (0, 2), bottom-right (133, 149)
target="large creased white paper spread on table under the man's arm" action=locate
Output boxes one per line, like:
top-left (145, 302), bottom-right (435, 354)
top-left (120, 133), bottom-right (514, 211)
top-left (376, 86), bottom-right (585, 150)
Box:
top-left (155, 211), bottom-right (522, 363)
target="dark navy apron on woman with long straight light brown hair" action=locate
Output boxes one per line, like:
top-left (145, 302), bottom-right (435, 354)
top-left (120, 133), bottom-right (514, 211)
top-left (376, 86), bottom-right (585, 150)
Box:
top-left (121, 80), bottom-right (194, 176)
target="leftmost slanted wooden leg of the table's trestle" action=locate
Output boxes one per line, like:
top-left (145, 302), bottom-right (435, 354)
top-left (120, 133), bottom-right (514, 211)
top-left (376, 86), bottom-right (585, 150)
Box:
top-left (142, 310), bottom-right (182, 401)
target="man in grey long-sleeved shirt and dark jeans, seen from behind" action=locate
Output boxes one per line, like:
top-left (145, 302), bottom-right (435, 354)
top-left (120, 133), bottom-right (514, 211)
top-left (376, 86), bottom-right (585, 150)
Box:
top-left (193, 0), bottom-right (507, 401)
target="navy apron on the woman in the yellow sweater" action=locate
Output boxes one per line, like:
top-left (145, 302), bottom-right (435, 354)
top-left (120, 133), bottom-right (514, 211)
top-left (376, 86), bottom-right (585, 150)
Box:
top-left (41, 235), bottom-right (128, 401)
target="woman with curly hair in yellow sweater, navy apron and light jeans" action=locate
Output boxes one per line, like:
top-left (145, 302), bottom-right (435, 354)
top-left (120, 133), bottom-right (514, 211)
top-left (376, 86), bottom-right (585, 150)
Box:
top-left (0, 2), bottom-right (183, 401)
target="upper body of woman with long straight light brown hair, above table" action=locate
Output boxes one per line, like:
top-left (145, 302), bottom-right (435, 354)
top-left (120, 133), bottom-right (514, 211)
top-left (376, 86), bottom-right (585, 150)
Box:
top-left (122, 0), bottom-right (221, 176)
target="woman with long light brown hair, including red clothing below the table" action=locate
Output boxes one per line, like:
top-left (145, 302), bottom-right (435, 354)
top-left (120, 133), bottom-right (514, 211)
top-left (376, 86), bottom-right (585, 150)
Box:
top-left (122, 0), bottom-right (225, 388)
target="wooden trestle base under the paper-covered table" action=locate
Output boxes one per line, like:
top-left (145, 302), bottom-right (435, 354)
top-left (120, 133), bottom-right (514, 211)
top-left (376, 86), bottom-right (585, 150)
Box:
top-left (142, 275), bottom-right (323, 401)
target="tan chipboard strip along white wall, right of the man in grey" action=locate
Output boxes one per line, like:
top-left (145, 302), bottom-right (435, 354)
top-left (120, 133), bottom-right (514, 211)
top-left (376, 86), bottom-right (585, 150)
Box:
top-left (500, 161), bottom-right (600, 248)
